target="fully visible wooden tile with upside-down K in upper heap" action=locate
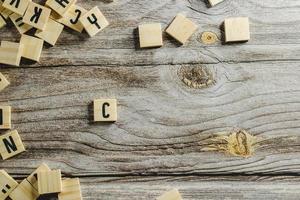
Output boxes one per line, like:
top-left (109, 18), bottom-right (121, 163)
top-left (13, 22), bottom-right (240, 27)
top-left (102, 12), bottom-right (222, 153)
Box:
top-left (23, 2), bottom-right (51, 30)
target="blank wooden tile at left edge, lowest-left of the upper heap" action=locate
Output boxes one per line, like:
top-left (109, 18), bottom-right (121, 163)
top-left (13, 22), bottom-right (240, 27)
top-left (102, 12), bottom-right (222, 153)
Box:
top-left (0, 41), bottom-right (23, 66)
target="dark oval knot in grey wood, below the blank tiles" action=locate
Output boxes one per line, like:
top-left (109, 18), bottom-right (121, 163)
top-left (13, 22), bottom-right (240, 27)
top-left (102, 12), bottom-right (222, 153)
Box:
top-left (178, 66), bottom-right (214, 89)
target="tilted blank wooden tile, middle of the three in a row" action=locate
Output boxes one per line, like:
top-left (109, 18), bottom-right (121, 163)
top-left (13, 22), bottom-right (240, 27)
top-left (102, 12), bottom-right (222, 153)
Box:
top-left (166, 14), bottom-right (198, 44)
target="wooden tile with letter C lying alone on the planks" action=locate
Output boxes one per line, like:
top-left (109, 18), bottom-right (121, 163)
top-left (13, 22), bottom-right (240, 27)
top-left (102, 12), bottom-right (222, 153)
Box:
top-left (94, 99), bottom-right (117, 122)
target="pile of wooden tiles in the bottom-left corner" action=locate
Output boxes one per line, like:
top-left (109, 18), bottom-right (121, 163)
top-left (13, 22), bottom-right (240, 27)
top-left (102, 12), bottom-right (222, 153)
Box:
top-left (0, 164), bottom-right (82, 200)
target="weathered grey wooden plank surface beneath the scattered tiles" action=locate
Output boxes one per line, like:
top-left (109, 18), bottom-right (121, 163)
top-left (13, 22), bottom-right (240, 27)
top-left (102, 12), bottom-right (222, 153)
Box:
top-left (0, 0), bottom-right (300, 200)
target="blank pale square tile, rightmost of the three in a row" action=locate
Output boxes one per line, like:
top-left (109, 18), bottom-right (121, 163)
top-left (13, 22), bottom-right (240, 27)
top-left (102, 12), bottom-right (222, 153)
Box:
top-left (224, 17), bottom-right (250, 42)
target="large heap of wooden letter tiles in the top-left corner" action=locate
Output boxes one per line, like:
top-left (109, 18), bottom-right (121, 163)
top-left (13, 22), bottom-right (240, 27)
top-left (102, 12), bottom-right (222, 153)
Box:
top-left (0, 0), bottom-right (109, 66)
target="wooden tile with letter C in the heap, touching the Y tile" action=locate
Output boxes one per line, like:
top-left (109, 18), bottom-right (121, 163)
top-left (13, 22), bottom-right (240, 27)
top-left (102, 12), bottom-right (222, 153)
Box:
top-left (57, 5), bottom-right (87, 33)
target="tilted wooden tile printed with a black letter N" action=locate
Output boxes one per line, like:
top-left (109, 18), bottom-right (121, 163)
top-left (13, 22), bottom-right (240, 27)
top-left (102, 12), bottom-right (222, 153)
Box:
top-left (0, 130), bottom-right (25, 160)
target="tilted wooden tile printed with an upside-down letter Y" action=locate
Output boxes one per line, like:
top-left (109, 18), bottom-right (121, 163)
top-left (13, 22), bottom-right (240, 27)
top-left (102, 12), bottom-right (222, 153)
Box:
top-left (79, 6), bottom-right (109, 37)
